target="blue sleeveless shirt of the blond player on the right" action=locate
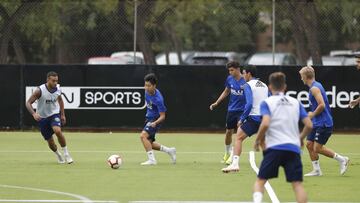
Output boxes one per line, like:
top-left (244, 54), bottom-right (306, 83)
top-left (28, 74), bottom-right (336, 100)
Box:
top-left (309, 81), bottom-right (333, 127)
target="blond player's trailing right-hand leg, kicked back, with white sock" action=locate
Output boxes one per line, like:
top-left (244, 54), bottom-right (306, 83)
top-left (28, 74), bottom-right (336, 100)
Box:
top-left (314, 127), bottom-right (349, 175)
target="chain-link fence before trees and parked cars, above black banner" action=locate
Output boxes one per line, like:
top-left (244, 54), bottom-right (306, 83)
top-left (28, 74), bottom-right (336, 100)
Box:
top-left (0, 0), bottom-right (360, 65)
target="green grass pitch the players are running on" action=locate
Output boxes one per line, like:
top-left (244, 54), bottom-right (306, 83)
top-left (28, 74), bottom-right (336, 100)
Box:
top-left (0, 132), bottom-right (360, 202)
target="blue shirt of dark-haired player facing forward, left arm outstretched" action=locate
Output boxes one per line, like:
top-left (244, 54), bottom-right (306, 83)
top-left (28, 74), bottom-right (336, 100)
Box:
top-left (225, 75), bottom-right (246, 111)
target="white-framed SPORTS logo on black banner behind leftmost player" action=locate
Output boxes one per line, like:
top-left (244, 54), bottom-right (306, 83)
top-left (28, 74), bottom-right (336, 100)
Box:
top-left (25, 86), bottom-right (146, 110)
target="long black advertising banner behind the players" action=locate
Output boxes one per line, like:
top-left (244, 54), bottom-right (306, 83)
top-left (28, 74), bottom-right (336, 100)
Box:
top-left (0, 65), bottom-right (360, 130)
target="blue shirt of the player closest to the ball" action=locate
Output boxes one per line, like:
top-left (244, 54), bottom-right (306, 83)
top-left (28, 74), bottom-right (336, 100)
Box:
top-left (145, 89), bottom-right (166, 120)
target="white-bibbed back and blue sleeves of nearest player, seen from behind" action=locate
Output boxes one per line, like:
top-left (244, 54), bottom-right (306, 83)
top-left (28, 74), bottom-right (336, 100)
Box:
top-left (261, 93), bottom-right (306, 148)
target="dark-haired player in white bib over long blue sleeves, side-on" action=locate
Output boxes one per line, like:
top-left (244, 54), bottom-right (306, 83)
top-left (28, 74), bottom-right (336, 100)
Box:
top-left (221, 66), bottom-right (269, 173)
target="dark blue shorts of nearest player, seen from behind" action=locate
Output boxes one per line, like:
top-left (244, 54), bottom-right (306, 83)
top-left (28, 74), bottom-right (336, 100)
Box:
top-left (258, 149), bottom-right (303, 182)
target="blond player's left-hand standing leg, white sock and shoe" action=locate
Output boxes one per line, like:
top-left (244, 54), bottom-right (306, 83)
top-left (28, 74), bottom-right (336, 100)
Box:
top-left (304, 128), bottom-right (322, 176)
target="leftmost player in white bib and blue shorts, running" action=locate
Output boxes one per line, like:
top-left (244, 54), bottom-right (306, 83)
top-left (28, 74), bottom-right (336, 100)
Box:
top-left (26, 71), bottom-right (73, 164)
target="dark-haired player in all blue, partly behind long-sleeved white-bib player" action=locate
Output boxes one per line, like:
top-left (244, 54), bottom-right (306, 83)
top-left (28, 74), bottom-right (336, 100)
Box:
top-left (210, 61), bottom-right (246, 164)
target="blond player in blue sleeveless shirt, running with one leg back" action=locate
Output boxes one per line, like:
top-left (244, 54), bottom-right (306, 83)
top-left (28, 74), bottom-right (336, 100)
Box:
top-left (299, 66), bottom-right (349, 176)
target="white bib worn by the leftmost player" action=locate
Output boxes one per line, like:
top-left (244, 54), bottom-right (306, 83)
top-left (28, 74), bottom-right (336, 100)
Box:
top-left (36, 84), bottom-right (61, 118)
